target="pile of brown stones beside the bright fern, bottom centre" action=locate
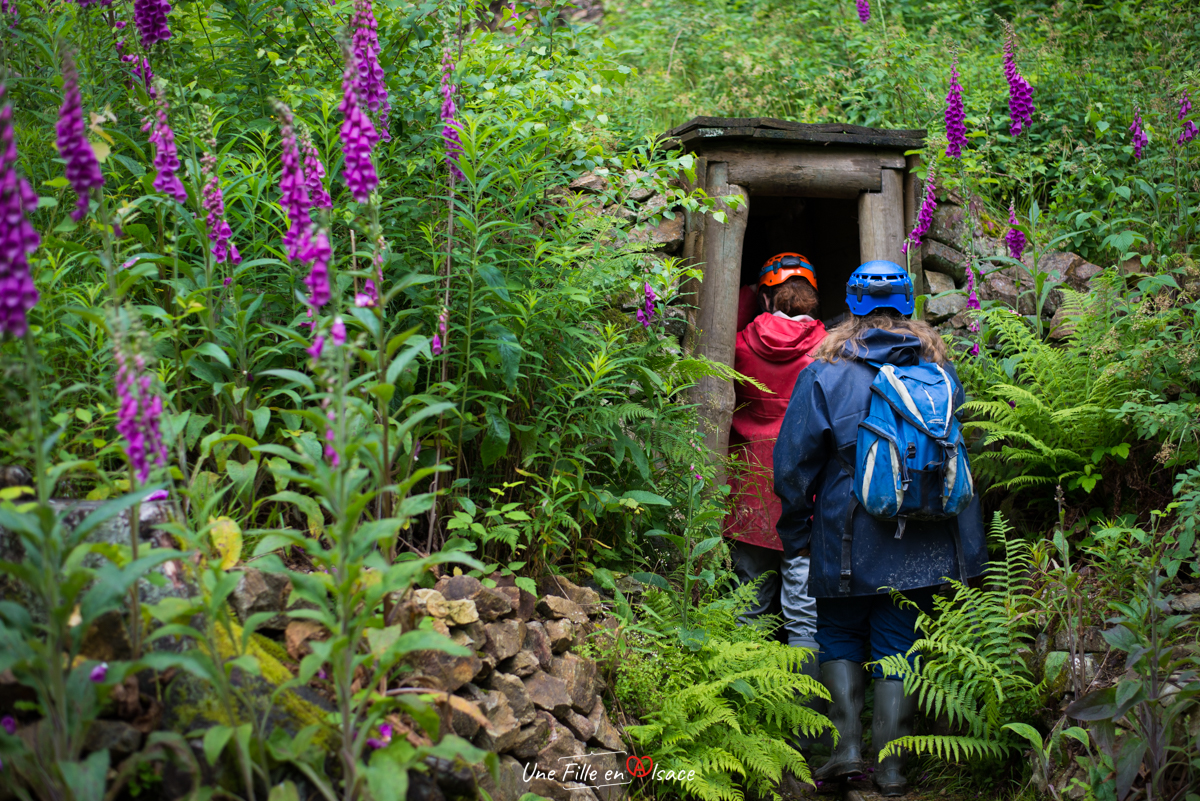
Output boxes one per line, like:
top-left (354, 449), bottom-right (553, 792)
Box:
top-left (402, 576), bottom-right (625, 801)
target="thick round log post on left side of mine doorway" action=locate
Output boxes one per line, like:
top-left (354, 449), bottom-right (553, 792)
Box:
top-left (694, 162), bottom-right (750, 462)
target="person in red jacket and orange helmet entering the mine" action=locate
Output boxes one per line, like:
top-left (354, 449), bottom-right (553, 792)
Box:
top-left (726, 253), bottom-right (826, 657)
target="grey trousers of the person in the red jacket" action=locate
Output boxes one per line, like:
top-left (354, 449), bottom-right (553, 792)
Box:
top-left (730, 541), bottom-right (818, 651)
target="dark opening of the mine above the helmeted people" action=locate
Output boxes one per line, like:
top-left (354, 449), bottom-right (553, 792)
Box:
top-left (740, 194), bottom-right (859, 320)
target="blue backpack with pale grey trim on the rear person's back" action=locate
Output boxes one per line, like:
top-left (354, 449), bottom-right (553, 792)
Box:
top-left (853, 361), bottom-right (974, 540)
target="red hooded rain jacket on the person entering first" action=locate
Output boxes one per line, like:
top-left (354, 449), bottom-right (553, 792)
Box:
top-left (725, 306), bottom-right (826, 550)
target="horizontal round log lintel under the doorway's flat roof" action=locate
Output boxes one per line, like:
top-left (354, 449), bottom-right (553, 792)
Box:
top-left (681, 141), bottom-right (881, 198)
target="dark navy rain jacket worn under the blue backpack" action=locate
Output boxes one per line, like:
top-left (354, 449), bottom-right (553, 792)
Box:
top-left (774, 329), bottom-right (988, 598)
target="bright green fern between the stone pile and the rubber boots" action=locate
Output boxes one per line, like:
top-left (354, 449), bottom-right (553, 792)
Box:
top-left (617, 574), bottom-right (829, 801)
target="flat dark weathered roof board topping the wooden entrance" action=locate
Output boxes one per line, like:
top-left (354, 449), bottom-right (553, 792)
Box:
top-left (667, 116), bottom-right (925, 150)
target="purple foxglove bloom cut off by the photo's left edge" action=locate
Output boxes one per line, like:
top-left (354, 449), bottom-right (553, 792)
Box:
top-left (0, 84), bottom-right (41, 337)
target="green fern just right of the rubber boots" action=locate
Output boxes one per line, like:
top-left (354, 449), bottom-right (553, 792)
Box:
top-left (878, 513), bottom-right (1042, 761)
